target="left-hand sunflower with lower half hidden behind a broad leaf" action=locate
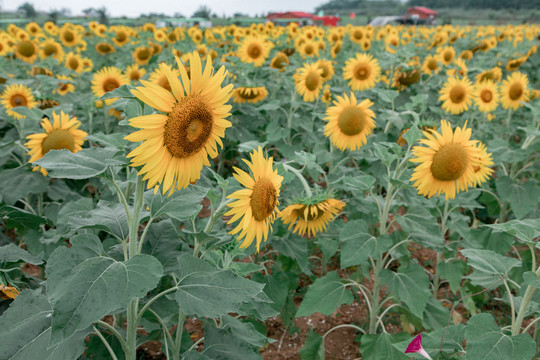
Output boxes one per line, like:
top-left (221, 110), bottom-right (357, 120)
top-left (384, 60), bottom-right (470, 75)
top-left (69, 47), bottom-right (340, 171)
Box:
top-left (24, 111), bottom-right (88, 175)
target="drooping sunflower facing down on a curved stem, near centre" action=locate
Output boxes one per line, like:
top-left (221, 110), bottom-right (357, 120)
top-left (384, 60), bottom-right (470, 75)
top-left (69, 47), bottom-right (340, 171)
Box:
top-left (280, 198), bottom-right (345, 237)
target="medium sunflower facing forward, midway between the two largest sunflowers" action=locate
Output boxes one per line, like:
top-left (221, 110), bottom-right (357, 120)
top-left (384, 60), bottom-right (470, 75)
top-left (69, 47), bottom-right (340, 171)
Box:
top-left (324, 92), bottom-right (375, 151)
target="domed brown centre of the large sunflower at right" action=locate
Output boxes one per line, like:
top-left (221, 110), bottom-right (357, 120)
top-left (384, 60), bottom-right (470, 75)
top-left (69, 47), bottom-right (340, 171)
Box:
top-left (431, 144), bottom-right (469, 181)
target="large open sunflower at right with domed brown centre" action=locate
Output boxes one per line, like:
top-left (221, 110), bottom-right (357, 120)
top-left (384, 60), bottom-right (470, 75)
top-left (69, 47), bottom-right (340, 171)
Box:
top-left (410, 120), bottom-right (491, 199)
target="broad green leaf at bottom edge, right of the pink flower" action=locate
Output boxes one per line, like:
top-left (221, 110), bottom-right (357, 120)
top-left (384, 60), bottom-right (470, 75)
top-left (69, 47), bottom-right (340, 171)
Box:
top-left (465, 314), bottom-right (536, 360)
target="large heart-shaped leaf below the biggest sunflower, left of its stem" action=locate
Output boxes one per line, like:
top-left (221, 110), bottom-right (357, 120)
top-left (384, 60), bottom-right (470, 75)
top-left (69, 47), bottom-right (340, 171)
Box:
top-left (47, 234), bottom-right (163, 345)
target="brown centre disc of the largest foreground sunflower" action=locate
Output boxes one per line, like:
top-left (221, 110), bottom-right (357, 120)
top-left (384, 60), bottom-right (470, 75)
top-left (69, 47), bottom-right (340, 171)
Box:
top-left (163, 95), bottom-right (214, 158)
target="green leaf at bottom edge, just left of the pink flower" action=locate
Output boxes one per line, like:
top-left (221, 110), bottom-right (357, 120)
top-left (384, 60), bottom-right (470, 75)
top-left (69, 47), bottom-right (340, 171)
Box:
top-left (360, 332), bottom-right (409, 360)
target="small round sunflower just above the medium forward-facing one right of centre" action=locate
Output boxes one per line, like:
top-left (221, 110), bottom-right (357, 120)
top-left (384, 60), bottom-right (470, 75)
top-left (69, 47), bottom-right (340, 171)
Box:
top-left (343, 53), bottom-right (381, 91)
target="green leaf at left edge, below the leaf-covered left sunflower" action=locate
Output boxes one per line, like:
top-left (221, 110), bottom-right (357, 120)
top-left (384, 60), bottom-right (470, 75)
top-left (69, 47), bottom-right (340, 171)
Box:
top-left (0, 167), bottom-right (49, 205)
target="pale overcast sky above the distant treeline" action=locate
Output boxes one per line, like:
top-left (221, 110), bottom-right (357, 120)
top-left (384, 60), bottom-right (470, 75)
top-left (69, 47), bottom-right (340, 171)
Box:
top-left (0, 0), bottom-right (327, 17)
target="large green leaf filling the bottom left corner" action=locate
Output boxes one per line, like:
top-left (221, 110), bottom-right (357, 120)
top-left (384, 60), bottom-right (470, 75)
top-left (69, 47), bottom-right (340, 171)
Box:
top-left (0, 289), bottom-right (92, 360)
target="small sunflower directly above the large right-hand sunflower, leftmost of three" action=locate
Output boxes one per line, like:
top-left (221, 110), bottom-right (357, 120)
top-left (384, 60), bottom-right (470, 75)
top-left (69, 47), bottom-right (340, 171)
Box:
top-left (439, 77), bottom-right (474, 114)
